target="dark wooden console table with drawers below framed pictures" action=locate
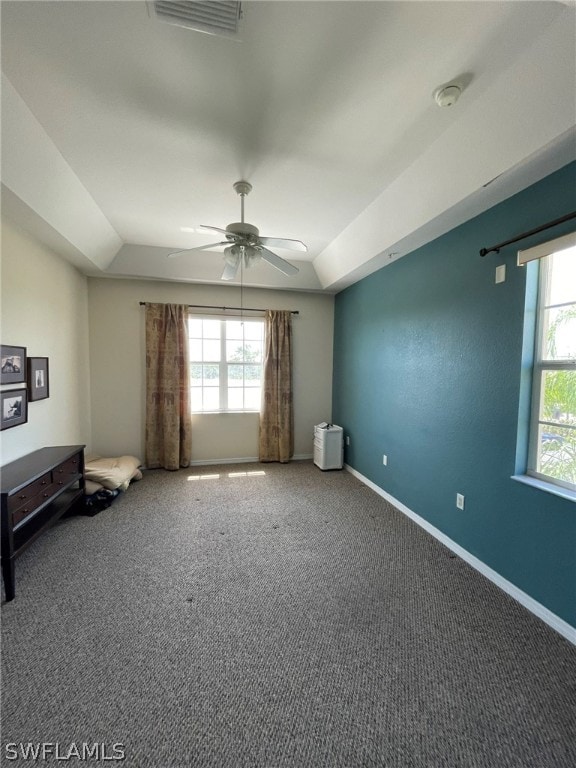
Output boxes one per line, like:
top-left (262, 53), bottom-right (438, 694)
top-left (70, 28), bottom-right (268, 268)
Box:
top-left (1, 445), bottom-right (85, 602)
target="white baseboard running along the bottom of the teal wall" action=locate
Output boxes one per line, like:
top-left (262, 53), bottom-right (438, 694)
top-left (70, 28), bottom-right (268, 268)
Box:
top-left (344, 464), bottom-right (576, 645)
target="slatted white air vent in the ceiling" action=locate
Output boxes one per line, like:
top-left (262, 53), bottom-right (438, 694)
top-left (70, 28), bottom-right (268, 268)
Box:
top-left (148, 0), bottom-right (241, 36)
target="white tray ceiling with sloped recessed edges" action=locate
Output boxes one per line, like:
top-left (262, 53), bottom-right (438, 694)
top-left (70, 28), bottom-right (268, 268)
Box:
top-left (1, 0), bottom-right (576, 292)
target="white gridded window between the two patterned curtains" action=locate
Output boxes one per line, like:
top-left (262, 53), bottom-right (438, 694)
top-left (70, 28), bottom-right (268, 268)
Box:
top-left (188, 317), bottom-right (264, 413)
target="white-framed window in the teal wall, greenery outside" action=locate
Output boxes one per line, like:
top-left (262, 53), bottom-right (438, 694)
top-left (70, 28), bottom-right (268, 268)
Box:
top-left (519, 233), bottom-right (576, 490)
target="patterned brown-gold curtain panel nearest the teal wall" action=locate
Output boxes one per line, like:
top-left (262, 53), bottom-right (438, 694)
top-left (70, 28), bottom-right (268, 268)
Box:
top-left (259, 309), bottom-right (294, 463)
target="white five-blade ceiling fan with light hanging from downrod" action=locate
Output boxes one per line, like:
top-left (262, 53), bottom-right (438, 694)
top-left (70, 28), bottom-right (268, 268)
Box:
top-left (168, 181), bottom-right (308, 280)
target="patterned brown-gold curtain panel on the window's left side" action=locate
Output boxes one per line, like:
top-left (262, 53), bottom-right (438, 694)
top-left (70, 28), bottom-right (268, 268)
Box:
top-left (146, 304), bottom-right (192, 469)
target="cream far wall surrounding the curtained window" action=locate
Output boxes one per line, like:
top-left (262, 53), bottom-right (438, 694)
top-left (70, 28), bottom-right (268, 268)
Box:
top-left (88, 278), bottom-right (334, 463)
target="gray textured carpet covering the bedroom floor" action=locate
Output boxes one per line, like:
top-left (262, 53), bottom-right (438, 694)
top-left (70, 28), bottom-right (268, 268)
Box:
top-left (2, 462), bottom-right (576, 768)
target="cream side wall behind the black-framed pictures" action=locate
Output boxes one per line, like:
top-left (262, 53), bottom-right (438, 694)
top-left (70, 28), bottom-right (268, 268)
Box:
top-left (0, 218), bottom-right (90, 464)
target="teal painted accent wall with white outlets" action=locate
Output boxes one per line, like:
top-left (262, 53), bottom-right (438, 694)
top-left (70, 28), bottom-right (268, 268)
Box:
top-left (332, 163), bottom-right (576, 626)
